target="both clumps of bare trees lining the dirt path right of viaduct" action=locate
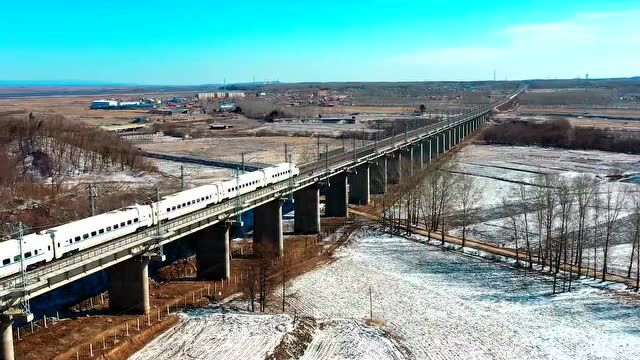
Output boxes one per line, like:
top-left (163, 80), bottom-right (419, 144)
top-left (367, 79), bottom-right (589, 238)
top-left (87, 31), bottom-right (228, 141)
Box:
top-left (383, 155), bottom-right (640, 293)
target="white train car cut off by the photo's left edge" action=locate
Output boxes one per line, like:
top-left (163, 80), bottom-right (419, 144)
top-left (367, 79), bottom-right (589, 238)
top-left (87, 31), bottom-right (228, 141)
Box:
top-left (0, 233), bottom-right (54, 278)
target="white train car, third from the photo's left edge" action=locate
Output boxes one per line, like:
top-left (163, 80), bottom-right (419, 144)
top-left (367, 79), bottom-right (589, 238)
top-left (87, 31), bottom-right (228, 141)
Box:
top-left (153, 184), bottom-right (221, 223)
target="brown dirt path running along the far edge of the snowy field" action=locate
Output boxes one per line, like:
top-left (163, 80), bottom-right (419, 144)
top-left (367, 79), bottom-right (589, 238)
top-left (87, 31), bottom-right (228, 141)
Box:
top-left (349, 208), bottom-right (636, 288)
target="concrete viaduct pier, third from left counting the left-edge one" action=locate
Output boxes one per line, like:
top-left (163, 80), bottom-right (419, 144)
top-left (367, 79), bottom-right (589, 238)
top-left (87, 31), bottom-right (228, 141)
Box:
top-left (198, 221), bottom-right (231, 280)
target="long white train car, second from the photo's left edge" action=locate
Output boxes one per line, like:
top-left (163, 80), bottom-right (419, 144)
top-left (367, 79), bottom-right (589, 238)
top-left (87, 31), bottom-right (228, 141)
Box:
top-left (46, 204), bottom-right (153, 259)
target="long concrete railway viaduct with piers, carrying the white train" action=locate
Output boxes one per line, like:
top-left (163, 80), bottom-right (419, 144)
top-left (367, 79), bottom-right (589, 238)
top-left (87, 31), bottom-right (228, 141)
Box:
top-left (0, 88), bottom-right (525, 359)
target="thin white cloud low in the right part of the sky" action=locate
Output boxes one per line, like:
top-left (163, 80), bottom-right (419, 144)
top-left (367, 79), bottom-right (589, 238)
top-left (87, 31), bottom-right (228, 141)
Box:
top-left (396, 5), bottom-right (640, 78)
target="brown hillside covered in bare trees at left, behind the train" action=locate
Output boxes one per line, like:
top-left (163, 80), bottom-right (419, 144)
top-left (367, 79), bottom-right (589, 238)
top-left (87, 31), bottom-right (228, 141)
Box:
top-left (0, 114), bottom-right (152, 194)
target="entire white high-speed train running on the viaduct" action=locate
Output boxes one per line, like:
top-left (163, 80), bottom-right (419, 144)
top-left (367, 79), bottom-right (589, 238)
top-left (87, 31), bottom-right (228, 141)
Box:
top-left (0, 163), bottom-right (300, 278)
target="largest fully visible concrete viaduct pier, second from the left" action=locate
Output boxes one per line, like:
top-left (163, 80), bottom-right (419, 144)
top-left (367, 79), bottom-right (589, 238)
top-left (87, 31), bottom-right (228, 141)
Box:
top-left (109, 255), bottom-right (151, 314)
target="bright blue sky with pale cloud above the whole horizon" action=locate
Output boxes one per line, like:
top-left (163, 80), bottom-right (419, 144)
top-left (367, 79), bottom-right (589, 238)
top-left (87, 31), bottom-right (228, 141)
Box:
top-left (0, 0), bottom-right (640, 85)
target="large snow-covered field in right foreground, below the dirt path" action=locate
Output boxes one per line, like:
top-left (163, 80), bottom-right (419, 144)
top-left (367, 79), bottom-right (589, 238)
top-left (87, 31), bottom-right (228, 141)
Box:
top-left (289, 234), bottom-right (640, 359)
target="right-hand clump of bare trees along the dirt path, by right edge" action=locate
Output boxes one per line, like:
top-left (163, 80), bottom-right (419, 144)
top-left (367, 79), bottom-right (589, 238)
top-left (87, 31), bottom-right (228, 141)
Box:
top-left (503, 174), bottom-right (640, 290)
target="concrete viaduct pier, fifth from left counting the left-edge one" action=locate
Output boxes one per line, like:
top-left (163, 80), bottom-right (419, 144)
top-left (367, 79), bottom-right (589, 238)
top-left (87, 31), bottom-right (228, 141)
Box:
top-left (293, 184), bottom-right (320, 234)
